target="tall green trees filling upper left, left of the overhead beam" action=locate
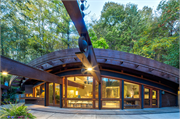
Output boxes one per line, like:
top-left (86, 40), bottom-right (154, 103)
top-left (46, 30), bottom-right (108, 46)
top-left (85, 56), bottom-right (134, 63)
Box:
top-left (1, 0), bottom-right (78, 63)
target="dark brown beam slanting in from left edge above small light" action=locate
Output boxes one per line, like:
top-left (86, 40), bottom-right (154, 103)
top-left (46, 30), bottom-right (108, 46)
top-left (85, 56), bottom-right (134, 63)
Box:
top-left (0, 56), bottom-right (62, 84)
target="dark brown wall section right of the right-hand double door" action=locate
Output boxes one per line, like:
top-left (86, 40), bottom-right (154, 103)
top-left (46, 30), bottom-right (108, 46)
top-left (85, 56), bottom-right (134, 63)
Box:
top-left (162, 92), bottom-right (176, 107)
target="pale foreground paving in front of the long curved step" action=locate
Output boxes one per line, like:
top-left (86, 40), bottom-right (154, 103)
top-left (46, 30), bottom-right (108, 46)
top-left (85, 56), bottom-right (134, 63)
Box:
top-left (30, 110), bottom-right (180, 119)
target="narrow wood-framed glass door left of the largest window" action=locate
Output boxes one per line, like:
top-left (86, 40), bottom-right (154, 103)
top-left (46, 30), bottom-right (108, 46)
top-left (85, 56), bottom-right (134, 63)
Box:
top-left (49, 83), bottom-right (60, 106)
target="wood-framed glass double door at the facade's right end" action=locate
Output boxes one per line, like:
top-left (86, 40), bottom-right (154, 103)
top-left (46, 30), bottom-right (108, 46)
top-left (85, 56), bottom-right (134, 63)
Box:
top-left (144, 87), bottom-right (158, 108)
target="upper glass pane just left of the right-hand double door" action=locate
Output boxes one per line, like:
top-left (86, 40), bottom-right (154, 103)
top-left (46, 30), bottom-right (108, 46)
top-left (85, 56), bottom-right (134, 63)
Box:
top-left (124, 82), bottom-right (139, 98)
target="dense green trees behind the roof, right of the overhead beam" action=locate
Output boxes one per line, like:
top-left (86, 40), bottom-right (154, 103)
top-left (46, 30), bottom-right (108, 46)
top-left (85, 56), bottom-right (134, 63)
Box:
top-left (91, 0), bottom-right (180, 68)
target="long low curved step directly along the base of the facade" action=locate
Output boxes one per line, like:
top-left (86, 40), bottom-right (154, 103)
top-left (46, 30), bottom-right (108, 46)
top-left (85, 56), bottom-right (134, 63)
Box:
top-left (27, 105), bottom-right (179, 115)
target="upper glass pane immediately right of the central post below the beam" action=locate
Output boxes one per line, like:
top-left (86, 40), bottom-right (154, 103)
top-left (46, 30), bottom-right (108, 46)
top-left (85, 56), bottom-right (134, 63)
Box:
top-left (102, 78), bottom-right (120, 98)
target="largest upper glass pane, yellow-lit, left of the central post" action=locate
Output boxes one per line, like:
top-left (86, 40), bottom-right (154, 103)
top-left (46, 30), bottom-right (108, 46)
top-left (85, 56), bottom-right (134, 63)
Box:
top-left (67, 76), bottom-right (93, 98)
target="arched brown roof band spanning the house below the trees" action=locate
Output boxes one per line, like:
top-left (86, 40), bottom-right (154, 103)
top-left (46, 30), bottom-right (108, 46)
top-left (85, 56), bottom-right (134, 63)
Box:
top-left (29, 48), bottom-right (179, 83)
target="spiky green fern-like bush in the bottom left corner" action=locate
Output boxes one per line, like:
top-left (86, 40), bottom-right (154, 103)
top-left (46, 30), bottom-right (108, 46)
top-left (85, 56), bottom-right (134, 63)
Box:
top-left (0, 103), bottom-right (36, 119)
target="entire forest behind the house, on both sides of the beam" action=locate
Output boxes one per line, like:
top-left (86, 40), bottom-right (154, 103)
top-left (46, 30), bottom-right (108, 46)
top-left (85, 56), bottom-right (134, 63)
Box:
top-left (0, 0), bottom-right (180, 68)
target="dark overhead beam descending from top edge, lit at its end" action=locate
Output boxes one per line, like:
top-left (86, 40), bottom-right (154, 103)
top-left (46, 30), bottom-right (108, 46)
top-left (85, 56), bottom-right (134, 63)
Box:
top-left (62, 0), bottom-right (100, 83)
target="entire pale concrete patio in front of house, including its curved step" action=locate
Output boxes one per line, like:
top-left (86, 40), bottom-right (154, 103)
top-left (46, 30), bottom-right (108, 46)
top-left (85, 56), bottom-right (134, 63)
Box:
top-left (0, 104), bottom-right (180, 119)
